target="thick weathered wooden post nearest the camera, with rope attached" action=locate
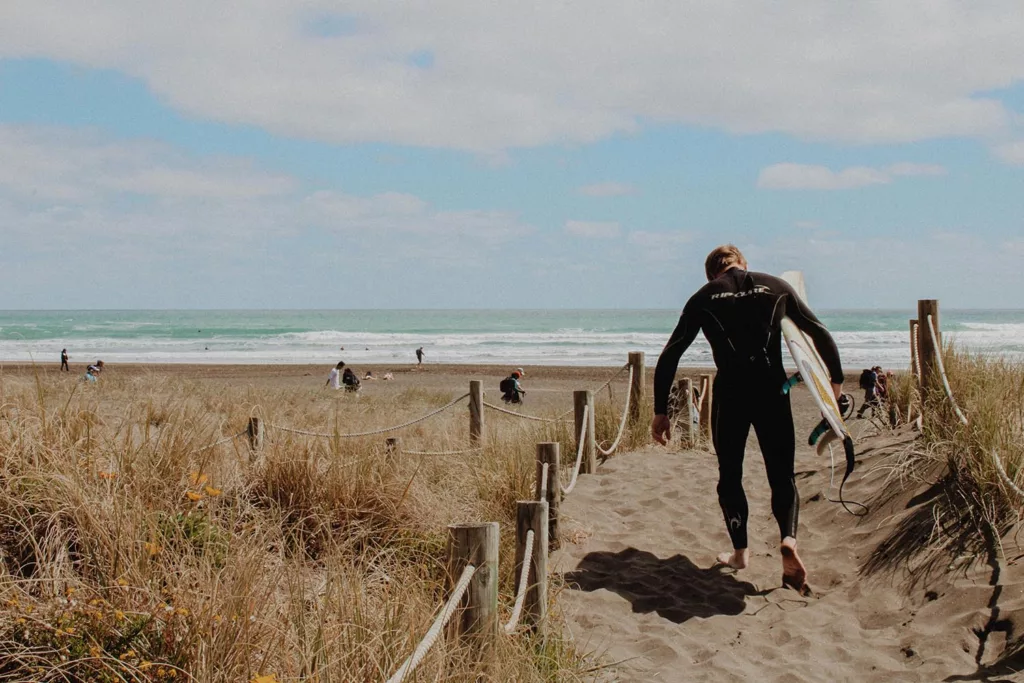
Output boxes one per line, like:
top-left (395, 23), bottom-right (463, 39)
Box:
top-left (447, 522), bottom-right (498, 648)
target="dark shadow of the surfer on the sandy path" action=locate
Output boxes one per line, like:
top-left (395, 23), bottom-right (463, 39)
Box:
top-left (563, 548), bottom-right (759, 624)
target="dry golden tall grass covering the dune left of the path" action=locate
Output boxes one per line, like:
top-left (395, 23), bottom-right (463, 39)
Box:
top-left (0, 374), bottom-right (630, 683)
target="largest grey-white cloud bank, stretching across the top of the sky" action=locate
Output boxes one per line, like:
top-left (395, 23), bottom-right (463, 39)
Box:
top-left (0, 0), bottom-right (1024, 152)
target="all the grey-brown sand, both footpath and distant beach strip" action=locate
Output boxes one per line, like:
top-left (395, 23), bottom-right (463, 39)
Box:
top-left (2, 359), bottom-right (1024, 683)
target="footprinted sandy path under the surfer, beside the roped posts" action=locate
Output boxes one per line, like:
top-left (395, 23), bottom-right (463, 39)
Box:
top-left (552, 423), bottom-right (1007, 682)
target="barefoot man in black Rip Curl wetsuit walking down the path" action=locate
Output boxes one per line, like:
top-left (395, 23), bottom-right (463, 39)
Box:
top-left (651, 245), bottom-right (843, 593)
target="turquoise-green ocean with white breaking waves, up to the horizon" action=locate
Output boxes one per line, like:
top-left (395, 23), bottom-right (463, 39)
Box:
top-left (0, 309), bottom-right (1024, 370)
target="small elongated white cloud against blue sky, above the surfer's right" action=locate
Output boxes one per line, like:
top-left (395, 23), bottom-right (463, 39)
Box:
top-left (758, 162), bottom-right (946, 189)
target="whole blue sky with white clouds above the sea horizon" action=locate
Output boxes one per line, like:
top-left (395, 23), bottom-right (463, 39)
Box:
top-left (0, 0), bottom-right (1024, 309)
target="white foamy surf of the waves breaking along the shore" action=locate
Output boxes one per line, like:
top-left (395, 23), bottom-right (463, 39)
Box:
top-left (0, 313), bottom-right (1024, 372)
